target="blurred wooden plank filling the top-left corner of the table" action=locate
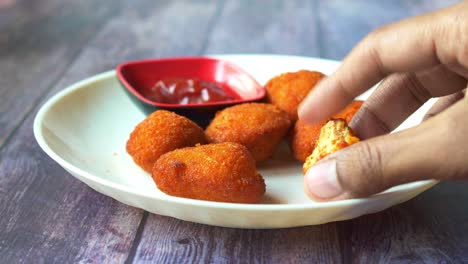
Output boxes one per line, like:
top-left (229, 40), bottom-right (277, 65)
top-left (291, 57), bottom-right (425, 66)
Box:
top-left (0, 0), bottom-right (119, 147)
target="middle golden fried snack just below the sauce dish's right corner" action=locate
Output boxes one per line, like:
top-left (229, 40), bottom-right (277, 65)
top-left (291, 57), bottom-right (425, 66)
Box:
top-left (205, 103), bottom-right (291, 161)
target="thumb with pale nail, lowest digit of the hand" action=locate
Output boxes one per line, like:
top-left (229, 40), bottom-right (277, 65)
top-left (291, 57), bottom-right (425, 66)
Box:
top-left (304, 100), bottom-right (468, 200)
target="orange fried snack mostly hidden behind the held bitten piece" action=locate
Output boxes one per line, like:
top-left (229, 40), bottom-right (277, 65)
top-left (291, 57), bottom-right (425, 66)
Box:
top-left (289, 100), bottom-right (364, 162)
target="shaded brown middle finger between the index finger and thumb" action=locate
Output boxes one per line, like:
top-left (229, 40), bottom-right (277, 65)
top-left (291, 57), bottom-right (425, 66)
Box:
top-left (350, 66), bottom-right (466, 139)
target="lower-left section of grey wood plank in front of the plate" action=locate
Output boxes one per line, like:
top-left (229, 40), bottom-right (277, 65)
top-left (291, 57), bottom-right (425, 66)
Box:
top-left (0, 136), bottom-right (142, 263)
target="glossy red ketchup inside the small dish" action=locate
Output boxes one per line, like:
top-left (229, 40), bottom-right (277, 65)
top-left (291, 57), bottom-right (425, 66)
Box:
top-left (143, 78), bottom-right (236, 105)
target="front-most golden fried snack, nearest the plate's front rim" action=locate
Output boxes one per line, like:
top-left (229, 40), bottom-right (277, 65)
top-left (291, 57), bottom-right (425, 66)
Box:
top-left (153, 142), bottom-right (265, 203)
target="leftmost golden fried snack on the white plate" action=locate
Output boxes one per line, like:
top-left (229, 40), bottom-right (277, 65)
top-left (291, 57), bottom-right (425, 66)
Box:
top-left (127, 110), bottom-right (206, 173)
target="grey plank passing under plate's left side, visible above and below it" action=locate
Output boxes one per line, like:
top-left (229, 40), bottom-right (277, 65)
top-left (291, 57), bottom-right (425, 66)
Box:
top-left (0, 0), bottom-right (218, 263)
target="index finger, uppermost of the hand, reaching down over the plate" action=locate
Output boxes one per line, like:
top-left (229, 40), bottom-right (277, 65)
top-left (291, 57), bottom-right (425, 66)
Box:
top-left (298, 3), bottom-right (467, 123)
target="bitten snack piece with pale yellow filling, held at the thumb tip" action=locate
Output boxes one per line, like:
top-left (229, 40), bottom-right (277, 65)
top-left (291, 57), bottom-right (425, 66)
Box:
top-left (302, 119), bottom-right (359, 174)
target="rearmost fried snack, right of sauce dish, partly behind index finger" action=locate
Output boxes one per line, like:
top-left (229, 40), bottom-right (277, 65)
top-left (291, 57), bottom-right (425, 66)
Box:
top-left (265, 70), bottom-right (325, 121)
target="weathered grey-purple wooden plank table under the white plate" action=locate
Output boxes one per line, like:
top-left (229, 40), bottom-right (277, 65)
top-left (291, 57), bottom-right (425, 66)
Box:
top-left (0, 0), bottom-right (468, 263)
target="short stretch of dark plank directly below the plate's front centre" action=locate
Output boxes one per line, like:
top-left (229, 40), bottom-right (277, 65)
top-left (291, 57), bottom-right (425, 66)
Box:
top-left (135, 215), bottom-right (341, 263)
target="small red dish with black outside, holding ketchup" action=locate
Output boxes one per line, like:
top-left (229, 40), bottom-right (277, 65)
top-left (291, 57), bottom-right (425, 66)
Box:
top-left (117, 57), bottom-right (265, 127)
